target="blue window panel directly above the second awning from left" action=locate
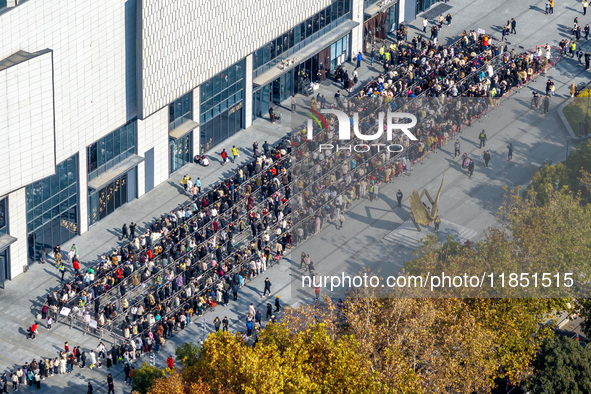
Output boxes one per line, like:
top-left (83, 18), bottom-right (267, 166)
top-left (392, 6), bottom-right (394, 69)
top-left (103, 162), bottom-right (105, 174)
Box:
top-left (86, 120), bottom-right (137, 181)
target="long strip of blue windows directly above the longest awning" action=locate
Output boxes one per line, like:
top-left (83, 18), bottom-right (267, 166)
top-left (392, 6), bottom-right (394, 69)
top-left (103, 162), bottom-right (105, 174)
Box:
top-left (253, 0), bottom-right (351, 77)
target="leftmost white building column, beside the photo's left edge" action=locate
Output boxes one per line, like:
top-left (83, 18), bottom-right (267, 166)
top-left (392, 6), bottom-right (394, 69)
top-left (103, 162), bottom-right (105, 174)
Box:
top-left (8, 187), bottom-right (29, 280)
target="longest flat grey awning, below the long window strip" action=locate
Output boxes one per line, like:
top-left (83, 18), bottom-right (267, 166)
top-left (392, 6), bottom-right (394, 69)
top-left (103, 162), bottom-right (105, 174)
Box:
top-left (252, 20), bottom-right (359, 86)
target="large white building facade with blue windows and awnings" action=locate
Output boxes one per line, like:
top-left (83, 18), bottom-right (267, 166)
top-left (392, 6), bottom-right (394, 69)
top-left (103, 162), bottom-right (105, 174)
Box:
top-left (0, 0), bottom-right (426, 287)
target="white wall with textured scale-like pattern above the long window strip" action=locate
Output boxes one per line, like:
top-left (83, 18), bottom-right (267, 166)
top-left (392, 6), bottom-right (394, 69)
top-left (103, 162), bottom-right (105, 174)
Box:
top-left (138, 0), bottom-right (331, 118)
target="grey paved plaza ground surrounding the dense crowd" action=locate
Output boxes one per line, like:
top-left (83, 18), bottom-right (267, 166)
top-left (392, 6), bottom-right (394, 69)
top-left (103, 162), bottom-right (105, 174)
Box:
top-left (0, 0), bottom-right (591, 393)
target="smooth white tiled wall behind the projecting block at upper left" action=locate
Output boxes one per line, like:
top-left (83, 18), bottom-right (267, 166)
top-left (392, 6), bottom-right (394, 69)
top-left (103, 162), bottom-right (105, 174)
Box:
top-left (0, 0), bottom-right (130, 168)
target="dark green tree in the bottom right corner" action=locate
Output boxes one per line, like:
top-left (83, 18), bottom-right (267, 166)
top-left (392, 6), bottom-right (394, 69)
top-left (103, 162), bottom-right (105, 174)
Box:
top-left (527, 337), bottom-right (591, 394)
